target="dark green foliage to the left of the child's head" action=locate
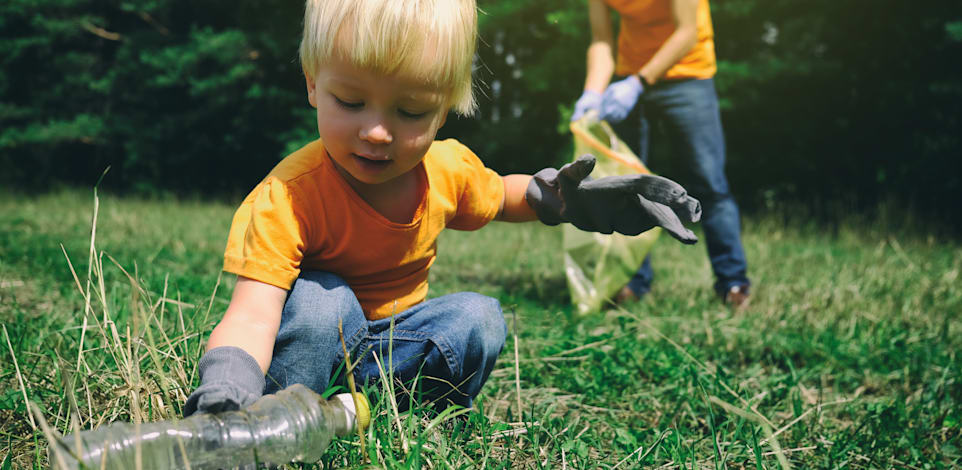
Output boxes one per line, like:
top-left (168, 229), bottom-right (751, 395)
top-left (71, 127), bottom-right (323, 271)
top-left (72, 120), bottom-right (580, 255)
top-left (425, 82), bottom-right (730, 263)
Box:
top-left (0, 0), bottom-right (304, 192)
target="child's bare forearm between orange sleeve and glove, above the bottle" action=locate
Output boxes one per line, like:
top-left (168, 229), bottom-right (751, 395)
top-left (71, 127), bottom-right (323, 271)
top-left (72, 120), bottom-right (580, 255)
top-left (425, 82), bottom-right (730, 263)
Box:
top-left (207, 276), bottom-right (287, 373)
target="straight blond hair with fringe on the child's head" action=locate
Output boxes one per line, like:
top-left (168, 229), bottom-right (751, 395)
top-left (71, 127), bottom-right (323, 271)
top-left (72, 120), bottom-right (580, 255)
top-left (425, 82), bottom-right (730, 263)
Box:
top-left (300, 0), bottom-right (477, 115)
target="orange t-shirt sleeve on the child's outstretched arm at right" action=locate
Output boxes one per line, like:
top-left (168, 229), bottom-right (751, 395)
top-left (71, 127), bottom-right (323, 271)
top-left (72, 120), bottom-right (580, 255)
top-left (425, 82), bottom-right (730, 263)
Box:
top-left (447, 143), bottom-right (504, 230)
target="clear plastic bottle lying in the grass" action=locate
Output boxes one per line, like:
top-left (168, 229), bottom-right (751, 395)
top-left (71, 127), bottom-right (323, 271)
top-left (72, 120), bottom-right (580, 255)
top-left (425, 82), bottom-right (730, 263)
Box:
top-left (48, 384), bottom-right (370, 470)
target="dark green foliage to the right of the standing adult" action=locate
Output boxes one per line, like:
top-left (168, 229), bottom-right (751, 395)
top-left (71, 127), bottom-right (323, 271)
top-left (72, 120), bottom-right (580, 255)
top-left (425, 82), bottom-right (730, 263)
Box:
top-left (713, 0), bottom-right (962, 219)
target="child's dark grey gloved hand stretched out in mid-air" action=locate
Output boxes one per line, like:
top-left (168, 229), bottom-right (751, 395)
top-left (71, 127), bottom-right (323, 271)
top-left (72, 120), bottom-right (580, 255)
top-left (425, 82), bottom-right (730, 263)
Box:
top-left (525, 155), bottom-right (701, 244)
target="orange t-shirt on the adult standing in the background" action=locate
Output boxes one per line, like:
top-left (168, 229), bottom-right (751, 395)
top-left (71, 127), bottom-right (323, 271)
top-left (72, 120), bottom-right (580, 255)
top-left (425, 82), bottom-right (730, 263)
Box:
top-left (605, 0), bottom-right (716, 80)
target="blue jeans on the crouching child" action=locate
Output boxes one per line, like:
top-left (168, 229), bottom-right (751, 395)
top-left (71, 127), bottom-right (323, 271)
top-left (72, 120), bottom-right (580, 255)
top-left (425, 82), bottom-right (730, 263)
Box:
top-left (264, 271), bottom-right (507, 407)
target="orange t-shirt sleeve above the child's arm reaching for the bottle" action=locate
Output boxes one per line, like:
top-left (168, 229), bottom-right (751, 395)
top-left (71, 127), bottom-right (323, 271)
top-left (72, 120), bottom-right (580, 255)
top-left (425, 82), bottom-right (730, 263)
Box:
top-left (224, 177), bottom-right (307, 289)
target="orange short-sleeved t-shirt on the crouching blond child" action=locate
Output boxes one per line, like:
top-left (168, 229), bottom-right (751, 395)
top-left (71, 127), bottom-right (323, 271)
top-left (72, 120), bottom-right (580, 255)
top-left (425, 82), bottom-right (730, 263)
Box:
top-left (224, 139), bottom-right (504, 320)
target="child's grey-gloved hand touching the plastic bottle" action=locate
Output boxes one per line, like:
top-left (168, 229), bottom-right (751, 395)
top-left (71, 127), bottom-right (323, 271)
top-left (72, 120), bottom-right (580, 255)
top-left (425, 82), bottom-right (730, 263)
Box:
top-left (184, 346), bottom-right (264, 418)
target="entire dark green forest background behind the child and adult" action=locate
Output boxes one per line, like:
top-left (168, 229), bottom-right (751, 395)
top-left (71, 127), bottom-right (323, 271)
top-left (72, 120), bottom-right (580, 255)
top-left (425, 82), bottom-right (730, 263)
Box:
top-left (0, 0), bottom-right (962, 228)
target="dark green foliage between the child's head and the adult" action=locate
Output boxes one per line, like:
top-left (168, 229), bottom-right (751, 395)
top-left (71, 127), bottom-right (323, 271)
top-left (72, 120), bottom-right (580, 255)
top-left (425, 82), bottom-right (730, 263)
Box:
top-left (441, 0), bottom-right (590, 173)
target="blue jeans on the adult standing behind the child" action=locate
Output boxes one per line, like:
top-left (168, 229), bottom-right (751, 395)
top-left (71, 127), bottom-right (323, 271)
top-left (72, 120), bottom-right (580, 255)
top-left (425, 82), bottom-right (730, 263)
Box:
top-left (618, 79), bottom-right (750, 295)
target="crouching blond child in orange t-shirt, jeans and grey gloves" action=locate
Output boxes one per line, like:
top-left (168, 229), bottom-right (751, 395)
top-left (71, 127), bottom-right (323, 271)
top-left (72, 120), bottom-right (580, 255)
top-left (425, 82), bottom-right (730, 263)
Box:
top-left (184, 0), bottom-right (700, 415)
